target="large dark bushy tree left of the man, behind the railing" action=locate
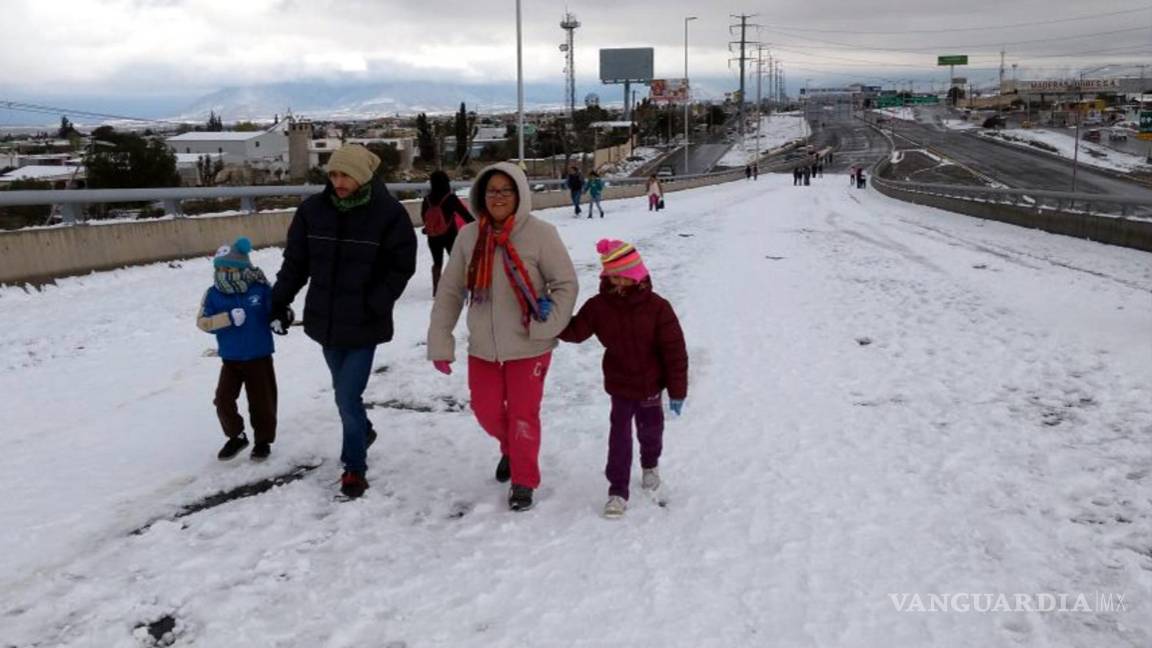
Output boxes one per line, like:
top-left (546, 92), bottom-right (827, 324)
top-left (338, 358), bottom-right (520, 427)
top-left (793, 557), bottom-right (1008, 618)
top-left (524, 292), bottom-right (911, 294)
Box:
top-left (84, 126), bottom-right (180, 189)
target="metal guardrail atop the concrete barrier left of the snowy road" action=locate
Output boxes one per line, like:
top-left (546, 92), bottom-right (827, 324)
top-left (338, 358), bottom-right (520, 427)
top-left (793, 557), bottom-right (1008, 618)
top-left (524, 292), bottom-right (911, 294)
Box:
top-left (0, 164), bottom-right (760, 225)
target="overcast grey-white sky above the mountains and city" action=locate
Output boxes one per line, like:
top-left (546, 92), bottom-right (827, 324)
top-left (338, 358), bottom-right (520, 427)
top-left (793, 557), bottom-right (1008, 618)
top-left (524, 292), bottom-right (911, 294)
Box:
top-left (0, 0), bottom-right (1152, 99)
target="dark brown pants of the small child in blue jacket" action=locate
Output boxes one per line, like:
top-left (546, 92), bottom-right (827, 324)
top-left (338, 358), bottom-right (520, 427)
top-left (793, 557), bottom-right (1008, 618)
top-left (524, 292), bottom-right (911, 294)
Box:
top-left (213, 355), bottom-right (276, 443)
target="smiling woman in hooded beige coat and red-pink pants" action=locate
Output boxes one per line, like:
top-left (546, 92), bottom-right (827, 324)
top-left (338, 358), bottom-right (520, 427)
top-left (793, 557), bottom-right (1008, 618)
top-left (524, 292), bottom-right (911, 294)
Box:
top-left (427, 163), bottom-right (577, 511)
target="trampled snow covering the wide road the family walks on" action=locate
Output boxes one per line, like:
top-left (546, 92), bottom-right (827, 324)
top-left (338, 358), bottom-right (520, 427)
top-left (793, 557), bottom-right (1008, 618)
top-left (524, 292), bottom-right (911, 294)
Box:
top-left (0, 175), bottom-right (1152, 648)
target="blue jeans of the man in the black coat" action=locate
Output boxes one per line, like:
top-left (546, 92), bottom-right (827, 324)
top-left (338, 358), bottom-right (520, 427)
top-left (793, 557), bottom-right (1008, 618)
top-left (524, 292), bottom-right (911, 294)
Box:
top-left (324, 346), bottom-right (376, 475)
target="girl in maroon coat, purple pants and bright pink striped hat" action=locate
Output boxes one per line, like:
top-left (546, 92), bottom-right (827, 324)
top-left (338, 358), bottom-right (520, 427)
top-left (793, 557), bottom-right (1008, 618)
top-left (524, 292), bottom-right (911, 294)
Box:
top-left (560, 239), bottom-right (688, 518)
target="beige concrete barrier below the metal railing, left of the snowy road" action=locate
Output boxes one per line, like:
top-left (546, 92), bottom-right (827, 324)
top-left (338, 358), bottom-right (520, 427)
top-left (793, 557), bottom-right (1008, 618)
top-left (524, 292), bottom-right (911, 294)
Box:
top-left (0, 173), bottom-right (743, 284)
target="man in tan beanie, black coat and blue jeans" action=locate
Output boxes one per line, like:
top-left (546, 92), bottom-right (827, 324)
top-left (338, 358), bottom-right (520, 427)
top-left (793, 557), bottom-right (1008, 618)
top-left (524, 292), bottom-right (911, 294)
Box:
top-left (272, 144), bottom-right (416, 497)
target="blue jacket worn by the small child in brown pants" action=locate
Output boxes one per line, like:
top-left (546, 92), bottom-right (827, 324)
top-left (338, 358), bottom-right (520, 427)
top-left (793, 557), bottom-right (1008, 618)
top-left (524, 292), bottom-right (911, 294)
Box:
top-left (197, 284), bottom-right (275, 360)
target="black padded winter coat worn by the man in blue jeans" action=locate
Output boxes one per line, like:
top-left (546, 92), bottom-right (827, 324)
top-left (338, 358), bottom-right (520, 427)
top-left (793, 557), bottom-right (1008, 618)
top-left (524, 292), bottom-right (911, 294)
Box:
top-left (272, 176), bottom-right (416, 348)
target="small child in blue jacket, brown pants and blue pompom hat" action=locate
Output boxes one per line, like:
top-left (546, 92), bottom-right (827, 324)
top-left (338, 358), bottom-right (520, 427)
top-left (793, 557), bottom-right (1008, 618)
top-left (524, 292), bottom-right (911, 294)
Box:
top-left (196, 236), bottom-right (276, 461)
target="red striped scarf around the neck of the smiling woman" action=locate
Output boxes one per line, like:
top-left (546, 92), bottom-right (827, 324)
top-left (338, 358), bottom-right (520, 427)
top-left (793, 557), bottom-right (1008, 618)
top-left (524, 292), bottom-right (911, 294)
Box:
top-left (468, 212), bottom-right (540, 329)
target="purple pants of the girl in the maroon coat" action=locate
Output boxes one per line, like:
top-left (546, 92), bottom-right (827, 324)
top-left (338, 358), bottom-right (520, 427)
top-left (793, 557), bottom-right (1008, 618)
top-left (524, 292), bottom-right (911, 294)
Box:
top-left (604, 394), bottom-right (664, 499)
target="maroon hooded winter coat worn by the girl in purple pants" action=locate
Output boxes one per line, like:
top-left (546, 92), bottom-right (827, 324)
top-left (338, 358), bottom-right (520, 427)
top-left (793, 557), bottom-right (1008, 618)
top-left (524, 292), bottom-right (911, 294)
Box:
top-left (560, 279), bottom-right (688, 400)
